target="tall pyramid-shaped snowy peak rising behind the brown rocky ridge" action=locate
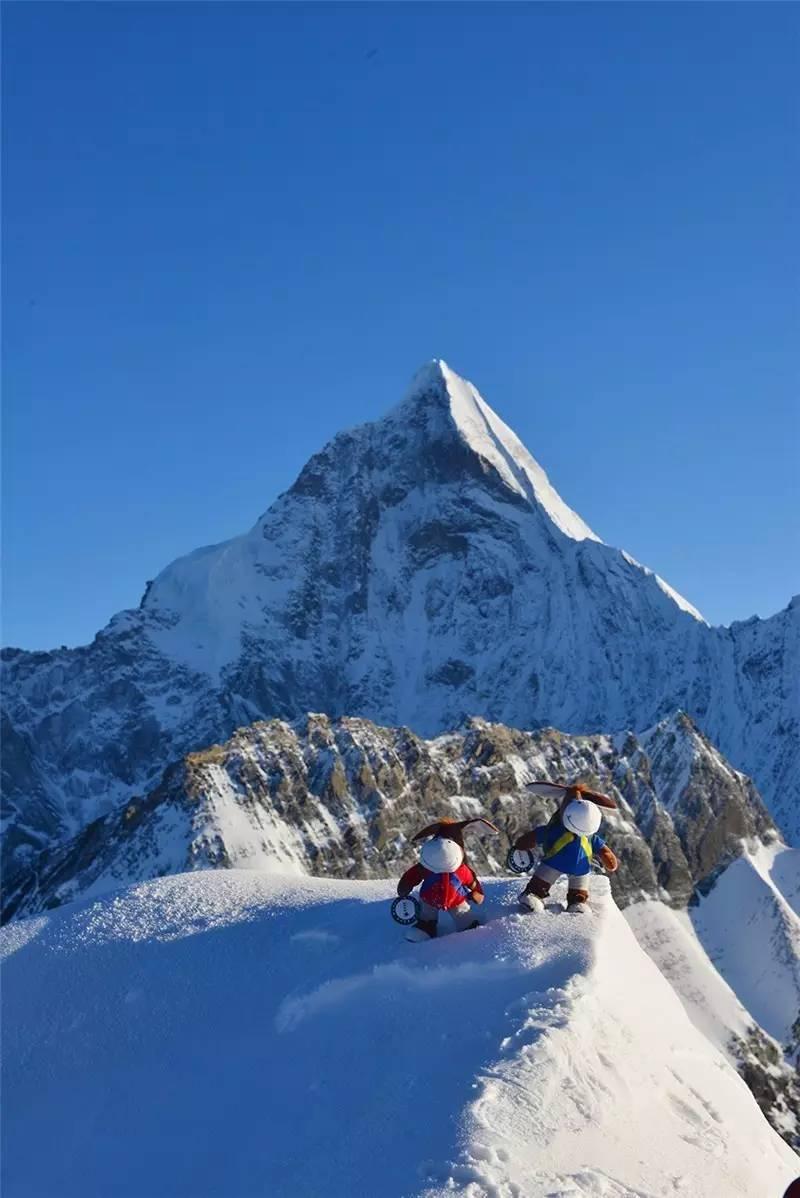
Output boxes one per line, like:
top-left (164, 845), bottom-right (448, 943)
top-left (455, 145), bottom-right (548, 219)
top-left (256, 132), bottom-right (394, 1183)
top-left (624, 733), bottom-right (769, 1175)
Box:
top-left (2, 363), bottom-right (800, 879)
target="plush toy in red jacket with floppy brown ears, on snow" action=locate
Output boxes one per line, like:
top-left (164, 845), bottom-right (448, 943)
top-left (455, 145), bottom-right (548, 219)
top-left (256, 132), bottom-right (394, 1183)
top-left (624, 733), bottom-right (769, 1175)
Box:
top-left (398, 818), bottom-right (498, 940)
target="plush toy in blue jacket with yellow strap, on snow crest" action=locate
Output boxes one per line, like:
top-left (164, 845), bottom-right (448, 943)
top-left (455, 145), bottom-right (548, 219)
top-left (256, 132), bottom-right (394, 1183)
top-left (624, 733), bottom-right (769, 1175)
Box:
top-left (511, 782), bottom-right (618, 914)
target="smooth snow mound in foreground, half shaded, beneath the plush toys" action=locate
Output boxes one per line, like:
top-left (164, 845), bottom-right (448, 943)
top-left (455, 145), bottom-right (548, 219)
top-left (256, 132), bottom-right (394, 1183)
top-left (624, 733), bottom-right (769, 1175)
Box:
top-left (2, 871), bottom-right (798, 1198)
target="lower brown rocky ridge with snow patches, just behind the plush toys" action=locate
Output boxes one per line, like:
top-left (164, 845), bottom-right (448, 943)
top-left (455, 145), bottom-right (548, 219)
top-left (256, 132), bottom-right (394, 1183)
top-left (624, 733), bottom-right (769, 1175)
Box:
top-left (5, 715), bottom-right (776, 918)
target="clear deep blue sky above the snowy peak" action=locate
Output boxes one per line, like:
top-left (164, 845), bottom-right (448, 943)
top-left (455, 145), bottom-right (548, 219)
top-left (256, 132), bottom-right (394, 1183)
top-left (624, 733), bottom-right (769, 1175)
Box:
top-left (2, 4), bottom-right (800, 648)
